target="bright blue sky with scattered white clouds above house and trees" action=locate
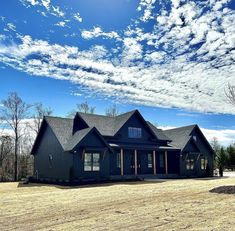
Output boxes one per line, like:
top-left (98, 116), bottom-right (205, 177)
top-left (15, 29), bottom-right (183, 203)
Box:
top-left (0, 0), bottom-right (235, 144)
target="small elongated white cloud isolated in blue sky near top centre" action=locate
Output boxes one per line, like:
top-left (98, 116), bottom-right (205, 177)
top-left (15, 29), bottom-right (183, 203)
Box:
top-left (81, 27), bottom-right (119, 39)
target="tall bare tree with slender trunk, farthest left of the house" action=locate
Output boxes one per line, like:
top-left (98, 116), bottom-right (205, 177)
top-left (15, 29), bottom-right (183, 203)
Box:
top-left (0, 92), bottom-right (30, 181)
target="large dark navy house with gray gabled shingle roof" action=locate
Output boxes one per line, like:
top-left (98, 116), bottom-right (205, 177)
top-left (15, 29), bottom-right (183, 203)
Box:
top-left (32, 110), bottom-right (213, 182)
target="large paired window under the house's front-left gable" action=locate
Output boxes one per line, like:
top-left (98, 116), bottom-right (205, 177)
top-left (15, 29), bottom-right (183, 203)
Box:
top-left (84, 153), bottom-right (100, 171)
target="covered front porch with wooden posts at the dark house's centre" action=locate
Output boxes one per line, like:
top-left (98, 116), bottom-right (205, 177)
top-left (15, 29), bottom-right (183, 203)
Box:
top-left (110, 144), bottom-right (180, 179)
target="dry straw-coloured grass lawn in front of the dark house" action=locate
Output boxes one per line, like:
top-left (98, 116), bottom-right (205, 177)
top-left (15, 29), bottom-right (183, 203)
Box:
top-left (0, 178), bottom-right (235, 231)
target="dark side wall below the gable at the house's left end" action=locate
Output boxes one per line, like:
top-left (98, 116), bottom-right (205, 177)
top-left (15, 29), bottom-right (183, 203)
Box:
top-left (34, 125), bottom-right (73, 181)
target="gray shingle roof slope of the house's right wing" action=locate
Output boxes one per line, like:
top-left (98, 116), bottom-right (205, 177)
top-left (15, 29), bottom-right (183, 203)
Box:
top-left (163, 124), bottom-right (197, 149)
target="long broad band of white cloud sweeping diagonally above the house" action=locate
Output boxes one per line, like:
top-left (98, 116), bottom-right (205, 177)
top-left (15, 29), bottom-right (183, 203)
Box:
top-left (0, 32), bottom-right (235, 113)
